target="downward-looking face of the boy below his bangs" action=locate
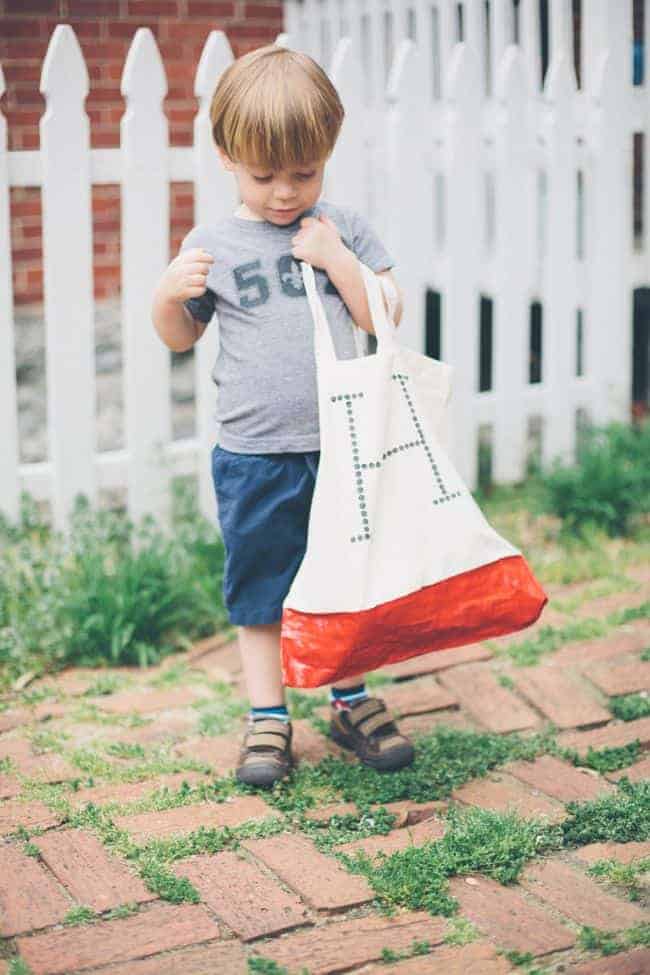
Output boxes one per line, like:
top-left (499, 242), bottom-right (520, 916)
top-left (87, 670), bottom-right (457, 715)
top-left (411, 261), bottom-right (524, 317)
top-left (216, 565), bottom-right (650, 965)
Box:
top-left (217, 147), bottom-right (327, 227)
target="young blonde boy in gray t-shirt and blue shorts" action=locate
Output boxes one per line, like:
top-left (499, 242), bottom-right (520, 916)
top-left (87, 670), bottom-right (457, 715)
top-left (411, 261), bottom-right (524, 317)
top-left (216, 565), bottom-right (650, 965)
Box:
top-left (152, 45), bottom-right (414, 787)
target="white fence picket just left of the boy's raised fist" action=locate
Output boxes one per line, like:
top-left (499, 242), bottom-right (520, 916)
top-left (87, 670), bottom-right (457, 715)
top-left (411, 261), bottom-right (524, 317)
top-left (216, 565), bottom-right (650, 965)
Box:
top-left (121, 27), bottom-right (172, 525)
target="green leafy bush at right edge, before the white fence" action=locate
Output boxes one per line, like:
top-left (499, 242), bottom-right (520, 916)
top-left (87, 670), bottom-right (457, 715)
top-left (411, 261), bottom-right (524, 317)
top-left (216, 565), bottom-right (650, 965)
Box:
top-left (539, 422), bottom-right (650, 536)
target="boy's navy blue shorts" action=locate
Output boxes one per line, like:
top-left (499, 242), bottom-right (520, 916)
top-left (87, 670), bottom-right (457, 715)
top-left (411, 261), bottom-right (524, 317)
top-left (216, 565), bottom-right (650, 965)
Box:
top-left (212, 444), bottom-right (320, 626)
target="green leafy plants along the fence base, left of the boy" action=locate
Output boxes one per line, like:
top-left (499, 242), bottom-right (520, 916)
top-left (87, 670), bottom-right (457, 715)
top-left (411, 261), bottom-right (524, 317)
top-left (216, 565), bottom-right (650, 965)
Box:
top-left (0, 485), bottom-right (226, 693)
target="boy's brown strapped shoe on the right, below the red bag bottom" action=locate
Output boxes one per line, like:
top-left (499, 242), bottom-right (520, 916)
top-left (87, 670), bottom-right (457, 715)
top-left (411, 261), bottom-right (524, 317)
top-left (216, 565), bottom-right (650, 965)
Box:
top-left (330, 697), bottom-right (415, 772)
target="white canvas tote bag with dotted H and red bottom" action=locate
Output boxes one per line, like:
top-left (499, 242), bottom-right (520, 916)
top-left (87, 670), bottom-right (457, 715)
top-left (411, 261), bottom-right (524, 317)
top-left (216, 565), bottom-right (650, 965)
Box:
top-left (281, 261), bottom-right (547, 687)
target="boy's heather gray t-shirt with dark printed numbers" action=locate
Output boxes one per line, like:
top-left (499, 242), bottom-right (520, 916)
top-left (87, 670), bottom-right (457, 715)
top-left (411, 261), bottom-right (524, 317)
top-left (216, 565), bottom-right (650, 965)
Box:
top-left (180, 199), bottom-right (395, 454)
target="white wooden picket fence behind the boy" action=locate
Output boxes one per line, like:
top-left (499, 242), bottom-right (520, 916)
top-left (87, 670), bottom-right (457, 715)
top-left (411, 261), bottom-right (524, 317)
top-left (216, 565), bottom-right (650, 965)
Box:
top-left (0, 0), bottom-right (636, 527)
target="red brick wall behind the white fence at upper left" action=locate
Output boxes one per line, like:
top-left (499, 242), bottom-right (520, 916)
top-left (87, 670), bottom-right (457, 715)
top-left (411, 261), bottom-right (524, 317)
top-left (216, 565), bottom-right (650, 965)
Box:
top-left (0, 0), bottom-right (283, 304)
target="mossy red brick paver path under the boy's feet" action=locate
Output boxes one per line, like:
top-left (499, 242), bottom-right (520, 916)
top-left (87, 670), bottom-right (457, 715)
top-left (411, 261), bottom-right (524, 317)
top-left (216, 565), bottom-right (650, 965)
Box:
top-left (0, 567), bottom-right (650, 975)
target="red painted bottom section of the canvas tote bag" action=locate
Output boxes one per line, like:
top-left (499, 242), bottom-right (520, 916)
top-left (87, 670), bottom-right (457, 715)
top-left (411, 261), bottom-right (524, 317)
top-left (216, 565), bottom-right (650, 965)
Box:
top-left (281, 555), bottom-right (548, 687)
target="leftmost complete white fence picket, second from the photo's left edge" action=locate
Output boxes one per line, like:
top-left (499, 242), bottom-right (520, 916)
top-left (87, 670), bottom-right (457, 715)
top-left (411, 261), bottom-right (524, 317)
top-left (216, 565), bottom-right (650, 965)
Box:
top-left (40, 24), bottom-right (96, 528)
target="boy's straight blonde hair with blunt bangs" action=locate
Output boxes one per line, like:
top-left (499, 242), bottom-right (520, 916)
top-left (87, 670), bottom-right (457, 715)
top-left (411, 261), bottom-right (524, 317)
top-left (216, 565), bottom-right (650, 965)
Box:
top-left (210, 44), bottom-right (345, 170)
